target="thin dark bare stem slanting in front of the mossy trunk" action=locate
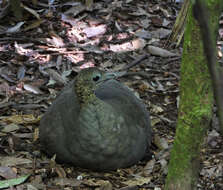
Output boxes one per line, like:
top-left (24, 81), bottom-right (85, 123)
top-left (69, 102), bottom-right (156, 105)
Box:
top-left (193, 0), bottom-right (223, 135)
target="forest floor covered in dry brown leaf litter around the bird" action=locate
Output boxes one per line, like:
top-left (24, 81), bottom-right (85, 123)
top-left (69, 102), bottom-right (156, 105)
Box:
top-left (0, 0), bottom-right (223, 190)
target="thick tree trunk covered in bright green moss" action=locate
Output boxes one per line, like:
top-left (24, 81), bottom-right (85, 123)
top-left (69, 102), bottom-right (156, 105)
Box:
top-left (165, 0), bottom-right (221, 190)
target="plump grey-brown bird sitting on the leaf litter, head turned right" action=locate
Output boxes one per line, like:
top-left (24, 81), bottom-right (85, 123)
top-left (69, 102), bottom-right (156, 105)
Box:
top-left (40, 68), bottom-right (151, 171)
